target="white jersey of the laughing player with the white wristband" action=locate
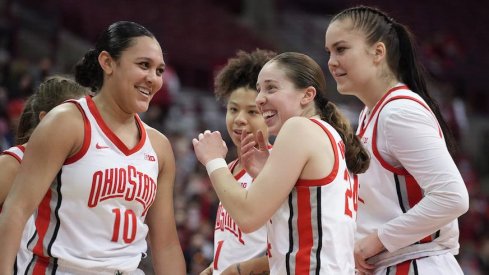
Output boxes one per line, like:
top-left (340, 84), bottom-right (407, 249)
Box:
top-left (267, 119), bottom-right (358, 275)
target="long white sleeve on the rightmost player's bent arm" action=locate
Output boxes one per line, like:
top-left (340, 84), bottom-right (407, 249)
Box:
top-left (378, 100), bottom-right (469, 251)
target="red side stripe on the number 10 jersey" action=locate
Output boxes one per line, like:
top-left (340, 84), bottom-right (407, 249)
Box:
top-left (32, 189), bottom-right (52, 257)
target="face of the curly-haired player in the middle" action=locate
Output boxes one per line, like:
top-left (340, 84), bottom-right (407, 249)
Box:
top-left (226, 87), bottom-right (268, 151)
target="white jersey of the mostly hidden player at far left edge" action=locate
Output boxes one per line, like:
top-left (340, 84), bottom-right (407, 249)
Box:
top-left (0, 145), bottom-right (36, 274)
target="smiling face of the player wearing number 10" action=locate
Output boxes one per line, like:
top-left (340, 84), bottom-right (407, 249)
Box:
top-left (106, 36), bottom-right (165, 113)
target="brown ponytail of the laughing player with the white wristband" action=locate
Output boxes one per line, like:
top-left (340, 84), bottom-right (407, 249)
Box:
top-left (318, 101), bottom-right (370, 174)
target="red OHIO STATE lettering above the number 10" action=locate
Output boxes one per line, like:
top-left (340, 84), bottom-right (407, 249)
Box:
top-left (88, 165), bottom-right (157, 216)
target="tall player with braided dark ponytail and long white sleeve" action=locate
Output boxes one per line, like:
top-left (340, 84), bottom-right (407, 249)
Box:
top-left (326, 6), bottom-right (468, 275)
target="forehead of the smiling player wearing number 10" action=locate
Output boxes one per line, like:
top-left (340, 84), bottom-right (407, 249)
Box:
top-left (123, 36), bottom-right (164, 64)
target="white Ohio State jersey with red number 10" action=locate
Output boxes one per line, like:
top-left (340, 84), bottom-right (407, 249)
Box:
top-left (28, 96), bottom-right (159, 274)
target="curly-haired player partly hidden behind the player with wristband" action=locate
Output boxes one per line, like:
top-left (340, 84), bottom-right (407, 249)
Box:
top-left (201, 50), bottom-right (275, 275)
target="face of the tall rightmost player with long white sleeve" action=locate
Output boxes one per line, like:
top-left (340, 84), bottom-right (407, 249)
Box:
top-left (325, 19), bottom-right (377, 98)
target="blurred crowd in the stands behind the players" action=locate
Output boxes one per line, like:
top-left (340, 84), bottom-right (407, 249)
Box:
top-left (0, 6), bottom-right (489, 274)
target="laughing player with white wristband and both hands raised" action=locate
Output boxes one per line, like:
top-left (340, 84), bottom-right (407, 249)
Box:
top-left (193, 53), bottom-right (369, 274)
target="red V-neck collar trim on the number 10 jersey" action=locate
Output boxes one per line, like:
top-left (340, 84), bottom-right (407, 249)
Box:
top-left (86, 96), bottom-right (146, 156)
